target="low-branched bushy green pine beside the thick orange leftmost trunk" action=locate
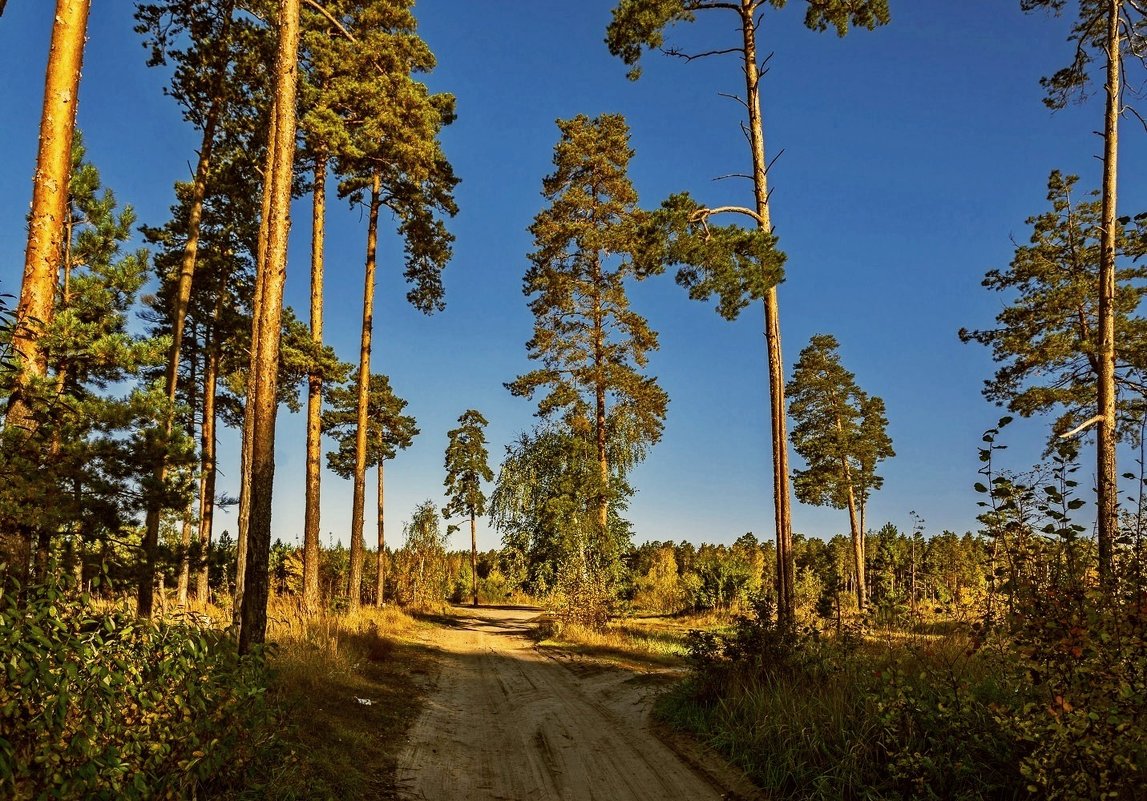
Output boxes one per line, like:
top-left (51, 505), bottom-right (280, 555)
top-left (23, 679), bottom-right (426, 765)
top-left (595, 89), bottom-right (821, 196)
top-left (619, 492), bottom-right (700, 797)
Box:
top-left (0, 134), bottom-right (190, 581)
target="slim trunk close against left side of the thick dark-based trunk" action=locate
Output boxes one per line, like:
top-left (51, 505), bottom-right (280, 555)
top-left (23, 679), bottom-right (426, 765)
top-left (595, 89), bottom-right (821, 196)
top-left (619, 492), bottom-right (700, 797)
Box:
top-left (232, 95), bottom-right (276, 630)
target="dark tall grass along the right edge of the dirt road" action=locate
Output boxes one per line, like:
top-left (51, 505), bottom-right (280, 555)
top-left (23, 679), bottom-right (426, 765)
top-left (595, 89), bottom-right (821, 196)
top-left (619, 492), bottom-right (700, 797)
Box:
top-left (656, 605), bottom-right (1028, 801)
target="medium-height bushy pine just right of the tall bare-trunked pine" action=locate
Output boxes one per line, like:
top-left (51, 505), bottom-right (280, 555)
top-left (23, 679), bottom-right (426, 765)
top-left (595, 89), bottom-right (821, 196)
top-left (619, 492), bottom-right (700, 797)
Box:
top-left (787, 334), bottom-right (895, 612)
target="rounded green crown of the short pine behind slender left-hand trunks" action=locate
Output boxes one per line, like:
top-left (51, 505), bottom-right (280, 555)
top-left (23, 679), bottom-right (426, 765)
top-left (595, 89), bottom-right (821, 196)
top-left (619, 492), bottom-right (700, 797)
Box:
top-left (322, 373), bottom-right (419, 479)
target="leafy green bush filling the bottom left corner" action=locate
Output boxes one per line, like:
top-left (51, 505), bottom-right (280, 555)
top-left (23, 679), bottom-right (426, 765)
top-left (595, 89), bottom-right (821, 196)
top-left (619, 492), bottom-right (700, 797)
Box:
top-left (0, 586), bottom-right (275, 800)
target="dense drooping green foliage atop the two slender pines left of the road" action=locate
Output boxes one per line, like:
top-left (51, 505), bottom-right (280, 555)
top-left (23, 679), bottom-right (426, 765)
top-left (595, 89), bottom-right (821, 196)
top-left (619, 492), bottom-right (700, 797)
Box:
top-left (301, 0), bottom-right (458, 313)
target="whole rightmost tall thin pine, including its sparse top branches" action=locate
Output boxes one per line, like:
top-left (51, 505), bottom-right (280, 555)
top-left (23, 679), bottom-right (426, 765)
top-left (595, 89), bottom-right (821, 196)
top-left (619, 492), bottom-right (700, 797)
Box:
top-left (1020, 0), bottom-right (1147, 584)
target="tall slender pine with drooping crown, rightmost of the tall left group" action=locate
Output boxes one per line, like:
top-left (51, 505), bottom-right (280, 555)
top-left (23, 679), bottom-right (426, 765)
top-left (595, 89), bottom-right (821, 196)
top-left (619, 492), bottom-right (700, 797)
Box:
top-left (325, 0), bottom-right (458, 607)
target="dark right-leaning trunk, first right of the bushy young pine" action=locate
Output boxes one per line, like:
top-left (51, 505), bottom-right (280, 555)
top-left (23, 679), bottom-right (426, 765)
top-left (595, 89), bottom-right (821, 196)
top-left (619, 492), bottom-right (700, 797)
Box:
top-left (135, 62), bottom-right (224, 617)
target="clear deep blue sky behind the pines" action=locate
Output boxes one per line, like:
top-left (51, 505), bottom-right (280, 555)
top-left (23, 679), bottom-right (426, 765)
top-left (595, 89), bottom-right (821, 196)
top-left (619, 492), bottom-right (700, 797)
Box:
top-left (0, 0), bottom-right (1147, 555)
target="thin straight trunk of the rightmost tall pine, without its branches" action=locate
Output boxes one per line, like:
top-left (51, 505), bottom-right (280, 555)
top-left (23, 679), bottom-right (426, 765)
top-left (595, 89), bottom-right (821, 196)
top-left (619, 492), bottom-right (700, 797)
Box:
top-left (1095, 0), bottom-right (1122, 589)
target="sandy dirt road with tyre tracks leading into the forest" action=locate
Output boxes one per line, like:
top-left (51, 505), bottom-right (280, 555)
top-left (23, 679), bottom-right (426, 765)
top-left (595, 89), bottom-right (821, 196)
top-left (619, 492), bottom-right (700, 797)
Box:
top-left (397, 607), bottom-right (721, 801)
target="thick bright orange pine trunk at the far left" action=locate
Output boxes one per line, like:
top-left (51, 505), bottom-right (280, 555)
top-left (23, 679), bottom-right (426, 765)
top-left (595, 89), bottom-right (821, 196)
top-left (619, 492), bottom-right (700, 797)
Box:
top-left (5, 0), bottom-right (91, 588)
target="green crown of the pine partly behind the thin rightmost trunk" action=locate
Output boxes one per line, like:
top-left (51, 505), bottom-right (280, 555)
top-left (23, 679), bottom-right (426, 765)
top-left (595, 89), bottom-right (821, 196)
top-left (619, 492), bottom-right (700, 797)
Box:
top-left (960, 171), bottom-right (1147, 443)
